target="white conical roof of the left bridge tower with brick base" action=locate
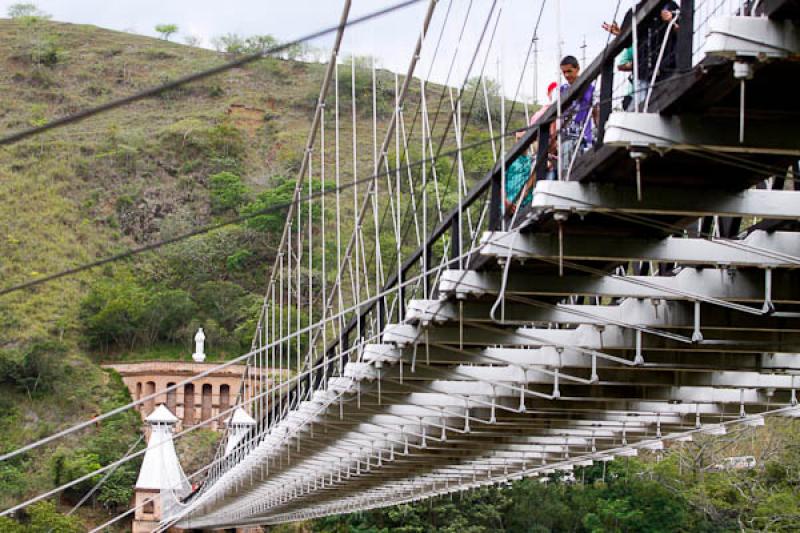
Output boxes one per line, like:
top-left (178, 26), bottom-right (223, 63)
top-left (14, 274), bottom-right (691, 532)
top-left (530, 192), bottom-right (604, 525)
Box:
top-left (136, 404), bottom-right (191, 491)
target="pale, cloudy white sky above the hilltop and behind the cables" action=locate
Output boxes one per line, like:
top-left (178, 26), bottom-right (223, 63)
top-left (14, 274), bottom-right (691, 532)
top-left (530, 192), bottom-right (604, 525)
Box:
top-left (0, 0), bottom-right (634, 101)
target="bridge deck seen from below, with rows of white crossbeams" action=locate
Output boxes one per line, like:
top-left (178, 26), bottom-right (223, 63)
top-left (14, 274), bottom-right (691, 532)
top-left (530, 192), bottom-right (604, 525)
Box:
top-left (172, 5), bottom-right (800, 527)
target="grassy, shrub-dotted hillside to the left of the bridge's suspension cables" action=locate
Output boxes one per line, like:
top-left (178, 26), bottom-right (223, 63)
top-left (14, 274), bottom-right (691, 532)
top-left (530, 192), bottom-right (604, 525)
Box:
top-left (0, 16), bottom-right (412, 523)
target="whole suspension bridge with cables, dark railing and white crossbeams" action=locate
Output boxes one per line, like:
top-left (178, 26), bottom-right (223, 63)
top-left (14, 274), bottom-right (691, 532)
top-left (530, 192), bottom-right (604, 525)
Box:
top-left (4, 0), bottom-right (800, 530)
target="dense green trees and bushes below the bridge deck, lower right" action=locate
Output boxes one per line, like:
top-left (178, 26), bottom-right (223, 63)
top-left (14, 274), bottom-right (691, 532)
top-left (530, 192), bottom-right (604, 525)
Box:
top-left (311, 420), bottom-right (800, 533)
